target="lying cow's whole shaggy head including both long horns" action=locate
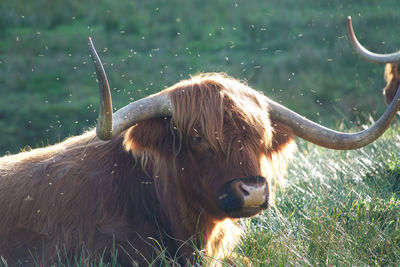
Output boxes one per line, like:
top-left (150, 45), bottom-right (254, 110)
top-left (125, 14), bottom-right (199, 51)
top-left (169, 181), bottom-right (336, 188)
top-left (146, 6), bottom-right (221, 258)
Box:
top-left (89, 27), bottom-right (400, 217)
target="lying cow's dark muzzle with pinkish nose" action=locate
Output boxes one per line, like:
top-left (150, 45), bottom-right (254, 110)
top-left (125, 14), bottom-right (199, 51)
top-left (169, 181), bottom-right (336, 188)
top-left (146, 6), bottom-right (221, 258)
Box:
top-left (218, 176), bottom-right (269, 218)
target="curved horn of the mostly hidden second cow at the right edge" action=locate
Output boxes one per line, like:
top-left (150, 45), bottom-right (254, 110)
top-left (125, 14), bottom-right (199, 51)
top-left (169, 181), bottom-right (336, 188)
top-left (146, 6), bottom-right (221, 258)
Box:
top-left (347, 16), bottom-right (400, 63)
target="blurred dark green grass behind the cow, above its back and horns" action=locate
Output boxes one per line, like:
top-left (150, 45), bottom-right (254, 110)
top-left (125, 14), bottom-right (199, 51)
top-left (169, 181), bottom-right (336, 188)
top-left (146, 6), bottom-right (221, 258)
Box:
top-left (0, 0), bottom-right (400, 155)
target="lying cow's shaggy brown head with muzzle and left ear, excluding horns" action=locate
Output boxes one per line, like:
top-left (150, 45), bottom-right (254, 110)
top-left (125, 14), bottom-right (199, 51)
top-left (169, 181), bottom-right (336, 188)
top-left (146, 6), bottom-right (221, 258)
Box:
top-left (125, 74), bottom-right (272, 217)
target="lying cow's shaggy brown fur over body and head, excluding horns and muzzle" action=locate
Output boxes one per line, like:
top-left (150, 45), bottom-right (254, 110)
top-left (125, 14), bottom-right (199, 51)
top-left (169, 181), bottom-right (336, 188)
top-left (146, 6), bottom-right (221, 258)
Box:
top-left (0, 74), bottom-right (295, 265)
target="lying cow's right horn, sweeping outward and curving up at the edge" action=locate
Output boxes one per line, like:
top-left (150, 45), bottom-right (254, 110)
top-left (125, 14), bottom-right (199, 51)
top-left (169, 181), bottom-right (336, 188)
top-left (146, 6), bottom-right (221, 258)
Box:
top-left (266, 84), bottom-right (400, 150)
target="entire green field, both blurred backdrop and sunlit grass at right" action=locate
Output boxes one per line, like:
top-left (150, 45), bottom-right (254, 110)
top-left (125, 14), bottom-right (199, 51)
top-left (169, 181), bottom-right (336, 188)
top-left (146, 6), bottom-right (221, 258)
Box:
top-left (0, 0), bottom-right (400, 266)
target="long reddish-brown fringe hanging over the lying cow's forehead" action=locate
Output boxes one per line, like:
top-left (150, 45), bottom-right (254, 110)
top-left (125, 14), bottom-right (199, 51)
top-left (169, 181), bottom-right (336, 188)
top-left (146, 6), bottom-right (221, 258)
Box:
top-left (167, 73), bottom-right (272, 154)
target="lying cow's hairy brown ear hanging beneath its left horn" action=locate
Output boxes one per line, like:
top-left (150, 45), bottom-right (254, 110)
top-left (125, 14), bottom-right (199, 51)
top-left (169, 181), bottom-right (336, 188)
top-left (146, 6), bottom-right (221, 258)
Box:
top-left (124, 118), bottom-right (171, 154)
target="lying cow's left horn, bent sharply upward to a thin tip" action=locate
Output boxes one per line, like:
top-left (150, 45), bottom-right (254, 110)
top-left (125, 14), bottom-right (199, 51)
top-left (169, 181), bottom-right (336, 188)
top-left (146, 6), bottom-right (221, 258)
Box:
top-left (89, 38), bottom-right (172, 140)
